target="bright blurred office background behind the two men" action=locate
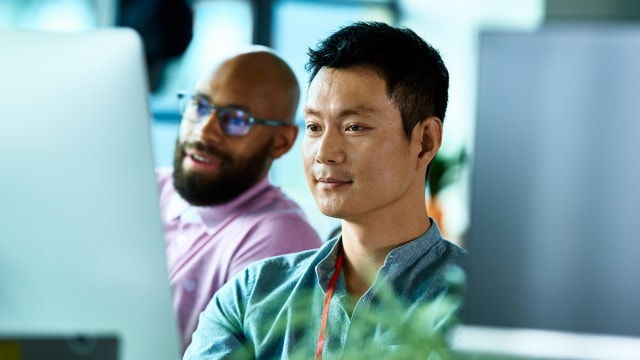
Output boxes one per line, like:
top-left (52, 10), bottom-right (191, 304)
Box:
top-left (0, 0), bottom-right (640, 244)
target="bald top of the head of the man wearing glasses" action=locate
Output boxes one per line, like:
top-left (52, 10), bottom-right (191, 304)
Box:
top-left (196, 45), bottom-right (300, 123)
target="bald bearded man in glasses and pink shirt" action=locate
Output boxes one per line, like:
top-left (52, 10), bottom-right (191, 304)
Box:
top-left (158, 46), bottom-right (322, 350)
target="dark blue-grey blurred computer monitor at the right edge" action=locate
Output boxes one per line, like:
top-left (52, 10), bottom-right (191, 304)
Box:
top-left (458, 23), bottom-right (640, 359)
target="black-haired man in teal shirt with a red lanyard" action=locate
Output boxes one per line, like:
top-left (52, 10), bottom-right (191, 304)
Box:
top-left (185, 22), bottom-right (466, 359)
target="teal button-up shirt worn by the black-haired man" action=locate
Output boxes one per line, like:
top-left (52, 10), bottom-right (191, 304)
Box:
top-left (184, 221), bottom-right (467, 360)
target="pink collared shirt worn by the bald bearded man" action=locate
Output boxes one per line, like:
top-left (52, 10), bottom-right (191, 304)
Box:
top-left (157, 168), bottom-right (322, 350)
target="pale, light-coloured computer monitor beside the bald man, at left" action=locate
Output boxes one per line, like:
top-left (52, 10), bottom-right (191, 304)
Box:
top-left (0, 28), bottom-right (179, 360)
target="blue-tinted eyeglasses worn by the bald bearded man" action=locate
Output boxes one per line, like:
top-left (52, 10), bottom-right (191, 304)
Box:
top-left (178, 93), bottom-right (289, 136)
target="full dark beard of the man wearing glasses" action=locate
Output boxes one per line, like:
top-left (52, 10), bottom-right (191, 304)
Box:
top-left (173, 139), bottom-right (273, 206)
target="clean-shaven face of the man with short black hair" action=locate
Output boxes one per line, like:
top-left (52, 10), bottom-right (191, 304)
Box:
top-left (302, 67), bottom-right (424, 221)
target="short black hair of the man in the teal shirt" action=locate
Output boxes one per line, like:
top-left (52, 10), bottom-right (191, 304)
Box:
top-left (305, 21), bottom-right (449, 137)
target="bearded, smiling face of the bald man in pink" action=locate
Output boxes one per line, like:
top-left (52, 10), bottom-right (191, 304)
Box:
top-left (174, 55), bottom-right (282, 206)
